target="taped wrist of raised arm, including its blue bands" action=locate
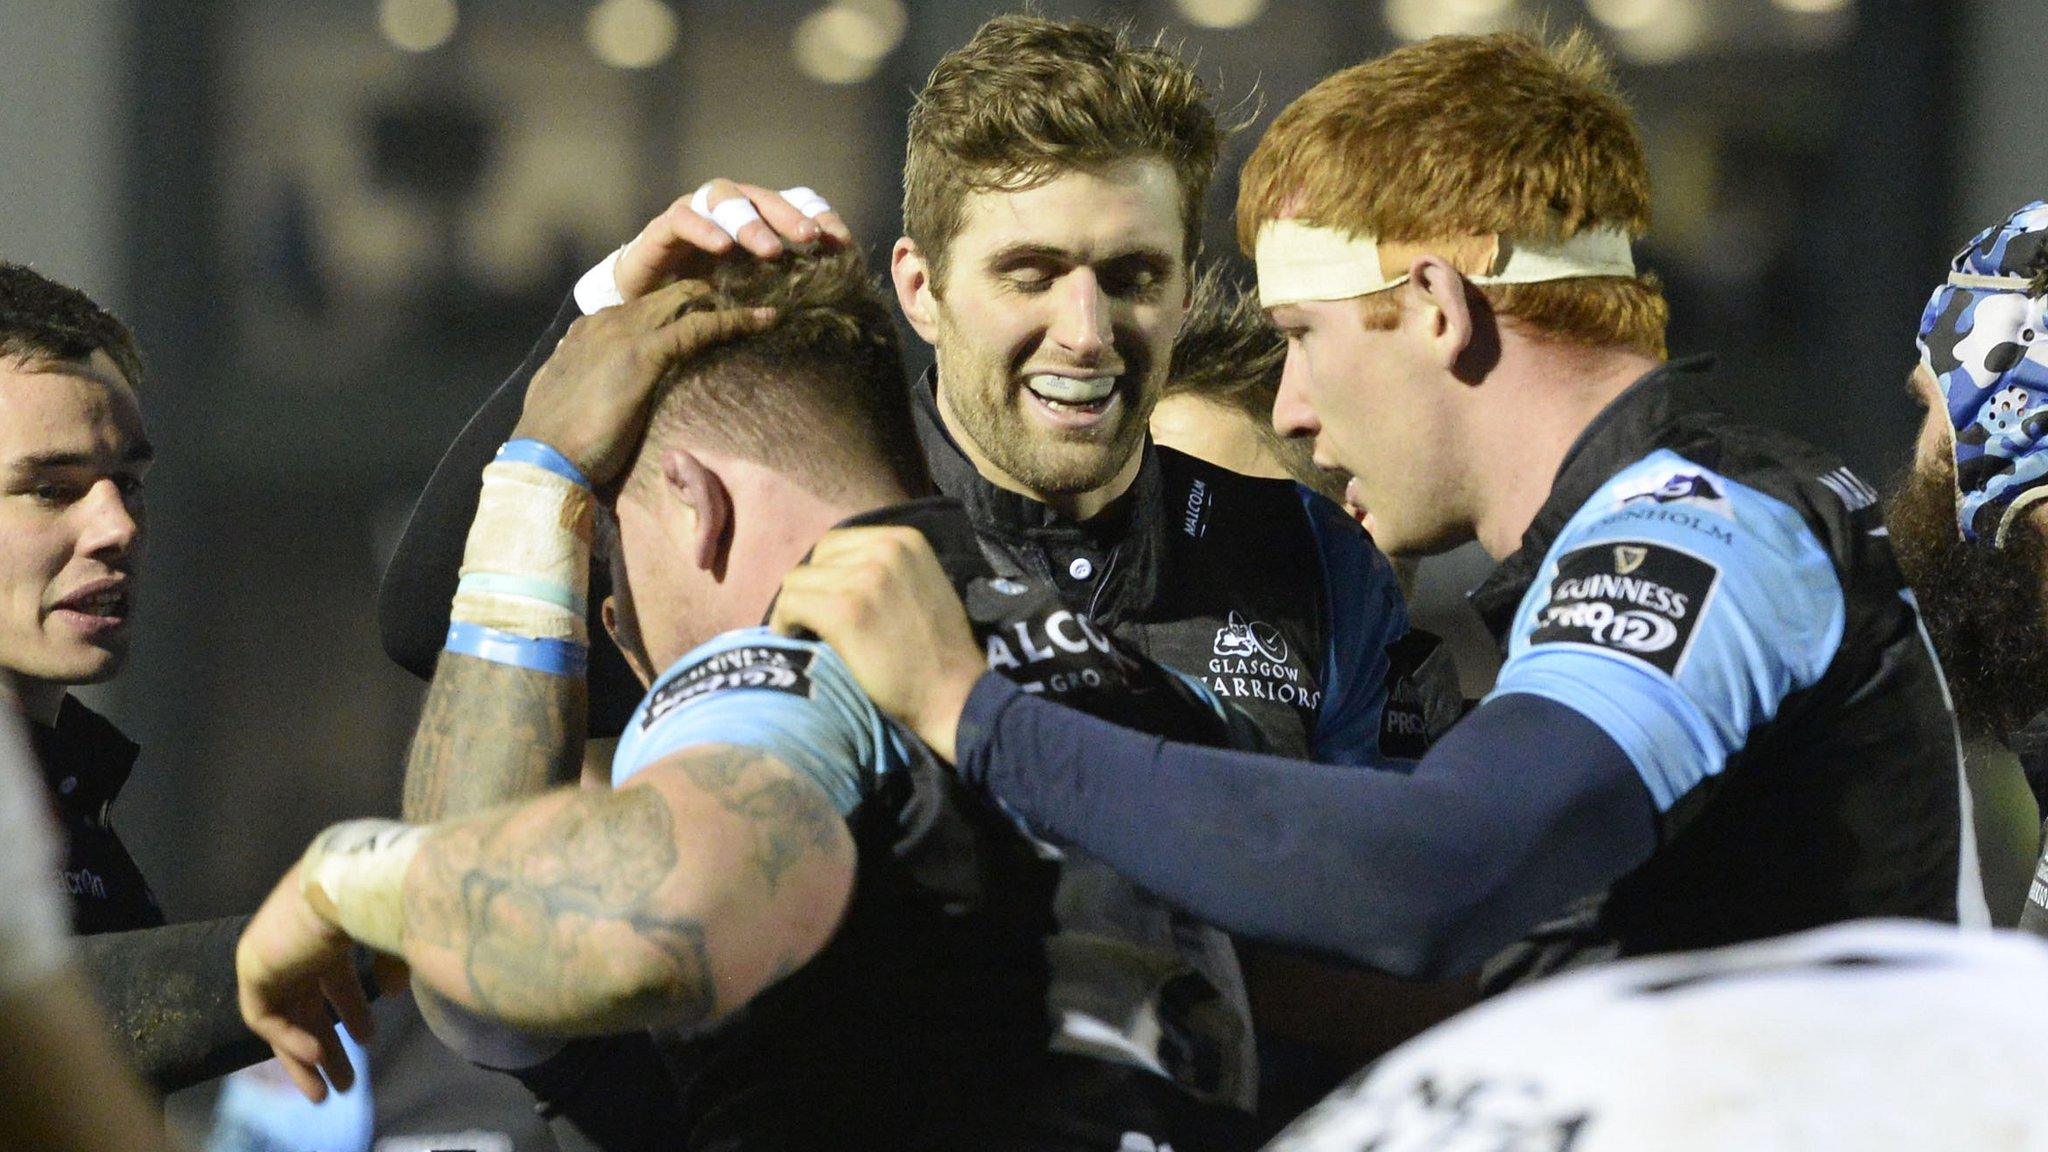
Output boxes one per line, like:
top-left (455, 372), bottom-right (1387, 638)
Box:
top-left (446, 441), bottom-right (594, 676)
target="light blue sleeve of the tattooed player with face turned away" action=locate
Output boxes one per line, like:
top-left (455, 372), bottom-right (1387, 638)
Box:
top-left (612, 627), bottom-right (901, 816)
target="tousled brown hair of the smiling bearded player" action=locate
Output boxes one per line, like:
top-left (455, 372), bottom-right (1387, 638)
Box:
top-left (903, 14), bottom-right (1223, 287)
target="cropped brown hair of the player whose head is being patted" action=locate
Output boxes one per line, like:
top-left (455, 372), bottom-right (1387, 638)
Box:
top-left (643, 250), bottom-right (930, 496)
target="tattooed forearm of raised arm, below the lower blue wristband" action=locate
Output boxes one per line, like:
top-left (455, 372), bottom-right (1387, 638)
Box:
top-left (406, 652), bottom-right (586, 822)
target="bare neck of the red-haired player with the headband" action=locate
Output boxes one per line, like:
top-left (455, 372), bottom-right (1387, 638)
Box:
top-left (1475, 338), bottom-right (1661, 560)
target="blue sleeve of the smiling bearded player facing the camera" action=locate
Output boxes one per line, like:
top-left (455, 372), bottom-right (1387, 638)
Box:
top-left (1300, 488), bottom-right (1409, 767)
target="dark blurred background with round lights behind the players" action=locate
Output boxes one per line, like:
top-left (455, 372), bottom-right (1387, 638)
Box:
top-left (0, 0), bottom-right (2048, 959)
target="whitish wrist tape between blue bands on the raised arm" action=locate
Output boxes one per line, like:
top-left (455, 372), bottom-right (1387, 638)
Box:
top-left (449, 461), bottom-right (594, 644)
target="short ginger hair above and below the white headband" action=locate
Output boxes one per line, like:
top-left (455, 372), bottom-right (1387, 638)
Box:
top-left (1237, 33), bottom-right (1669, 357)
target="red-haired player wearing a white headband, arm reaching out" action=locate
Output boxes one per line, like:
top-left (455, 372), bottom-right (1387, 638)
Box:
top-left (776, 35), bottom-right (1987, 988)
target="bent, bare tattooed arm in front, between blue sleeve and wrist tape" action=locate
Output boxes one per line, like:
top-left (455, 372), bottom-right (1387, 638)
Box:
top-left (406, 746), bottom-right (852, 1033)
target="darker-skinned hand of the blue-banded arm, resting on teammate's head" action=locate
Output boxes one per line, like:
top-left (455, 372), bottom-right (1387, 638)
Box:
top-left (512, 281), bottom-right (774, 492)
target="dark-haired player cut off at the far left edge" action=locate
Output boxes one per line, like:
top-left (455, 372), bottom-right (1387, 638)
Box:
top-left (0, 262), bottom-right (284, 1091)
